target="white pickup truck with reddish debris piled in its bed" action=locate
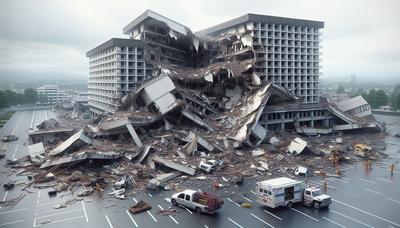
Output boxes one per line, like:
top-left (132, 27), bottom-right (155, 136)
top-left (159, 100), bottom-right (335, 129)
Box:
top-left (171, 189), bottom-right (224, 214)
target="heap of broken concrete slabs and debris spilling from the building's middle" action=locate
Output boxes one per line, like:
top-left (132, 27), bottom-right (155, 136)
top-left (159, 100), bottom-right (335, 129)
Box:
top-left (3, 21), bottom-right (390, 210)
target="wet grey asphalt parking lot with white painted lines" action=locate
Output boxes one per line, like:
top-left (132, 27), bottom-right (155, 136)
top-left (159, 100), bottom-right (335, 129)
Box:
top-left (0, 110), bottom-right (400, 228)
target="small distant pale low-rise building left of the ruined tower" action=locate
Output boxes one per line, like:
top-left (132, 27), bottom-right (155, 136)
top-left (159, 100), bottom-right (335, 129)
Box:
top-left (37, 85), bottom-right (71, 104)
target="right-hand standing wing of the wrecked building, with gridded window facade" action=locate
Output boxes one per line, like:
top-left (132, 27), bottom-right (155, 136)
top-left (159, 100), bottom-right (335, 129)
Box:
top-left (197, 14), bottom-right (324, 103)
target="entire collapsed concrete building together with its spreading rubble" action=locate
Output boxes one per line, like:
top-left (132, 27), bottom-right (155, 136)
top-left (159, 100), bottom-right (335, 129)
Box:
top-left (0, 11), bottom-right (388, 207)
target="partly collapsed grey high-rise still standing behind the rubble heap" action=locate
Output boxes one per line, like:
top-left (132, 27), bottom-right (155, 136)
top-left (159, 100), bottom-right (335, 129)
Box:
top-left (87, 10), bottom-right (381, 141)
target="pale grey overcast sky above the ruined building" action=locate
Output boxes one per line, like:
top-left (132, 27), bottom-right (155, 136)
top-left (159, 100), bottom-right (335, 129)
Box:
top-left (0, 0), bottom-right (400, 81)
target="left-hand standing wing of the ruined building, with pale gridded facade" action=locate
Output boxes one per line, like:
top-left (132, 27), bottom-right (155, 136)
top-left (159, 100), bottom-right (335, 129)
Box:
top-left (86, 38), bottom-right (151, 115)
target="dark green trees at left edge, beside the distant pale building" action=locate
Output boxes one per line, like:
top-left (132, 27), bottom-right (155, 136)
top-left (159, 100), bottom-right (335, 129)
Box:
top-left (0, 88), bottom-right (39, 109)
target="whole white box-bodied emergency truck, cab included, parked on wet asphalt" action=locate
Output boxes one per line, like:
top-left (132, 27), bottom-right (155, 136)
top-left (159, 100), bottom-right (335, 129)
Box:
top-left (256, 177), bottom-right (332, 209)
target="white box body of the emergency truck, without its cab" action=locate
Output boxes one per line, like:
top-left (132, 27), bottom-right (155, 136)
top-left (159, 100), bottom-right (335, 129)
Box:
top-left (257, 177), bottom-right (305, 208)
